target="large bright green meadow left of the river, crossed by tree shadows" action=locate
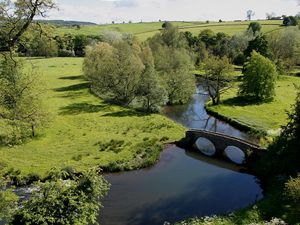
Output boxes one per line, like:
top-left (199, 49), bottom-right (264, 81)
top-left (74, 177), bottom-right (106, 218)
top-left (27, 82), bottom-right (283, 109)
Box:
top-left (0, 58), bottom-right (185, 177)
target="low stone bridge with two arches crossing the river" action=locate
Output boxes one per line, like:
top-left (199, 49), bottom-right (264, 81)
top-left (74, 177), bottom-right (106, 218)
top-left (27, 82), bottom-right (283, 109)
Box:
top-left (184, 129), bottom-right (263, 164)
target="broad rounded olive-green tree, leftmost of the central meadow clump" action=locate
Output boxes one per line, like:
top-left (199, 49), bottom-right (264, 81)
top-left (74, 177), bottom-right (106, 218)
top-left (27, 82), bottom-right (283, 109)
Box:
top-left (83, 42), bottom-right (144, 105)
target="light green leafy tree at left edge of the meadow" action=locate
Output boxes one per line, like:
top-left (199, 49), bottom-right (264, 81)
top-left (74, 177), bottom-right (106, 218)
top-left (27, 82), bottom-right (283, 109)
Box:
top-left (0, 57), bottom-right (48, 144)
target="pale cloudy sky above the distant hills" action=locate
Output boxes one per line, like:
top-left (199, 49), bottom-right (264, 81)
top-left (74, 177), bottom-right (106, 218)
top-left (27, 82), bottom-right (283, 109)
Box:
top-left (48, 0), bottom-right (300, 24)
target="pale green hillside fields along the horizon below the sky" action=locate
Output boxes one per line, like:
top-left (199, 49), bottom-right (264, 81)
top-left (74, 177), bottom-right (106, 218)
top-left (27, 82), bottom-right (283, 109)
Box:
top-left (56, 20), bottom-right (282, 41)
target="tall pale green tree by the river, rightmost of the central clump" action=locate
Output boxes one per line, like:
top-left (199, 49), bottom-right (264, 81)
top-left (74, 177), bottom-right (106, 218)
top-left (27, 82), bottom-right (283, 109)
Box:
top-left (148, 24), bottom-right (195, 104)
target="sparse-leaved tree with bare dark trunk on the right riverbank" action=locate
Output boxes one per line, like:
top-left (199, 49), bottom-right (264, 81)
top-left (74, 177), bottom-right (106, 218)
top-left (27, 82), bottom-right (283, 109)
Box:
top-left (204, 56), bottom-right (233, 105)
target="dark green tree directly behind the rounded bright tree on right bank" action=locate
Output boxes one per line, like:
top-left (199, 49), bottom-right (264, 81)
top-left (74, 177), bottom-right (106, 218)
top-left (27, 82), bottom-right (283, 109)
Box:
top-left (244, 35), bottom-right (270, 57)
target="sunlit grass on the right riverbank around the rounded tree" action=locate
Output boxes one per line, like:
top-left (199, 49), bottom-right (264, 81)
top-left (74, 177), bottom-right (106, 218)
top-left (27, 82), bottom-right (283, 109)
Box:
top-left (208, 76), bottom-right (300, 135)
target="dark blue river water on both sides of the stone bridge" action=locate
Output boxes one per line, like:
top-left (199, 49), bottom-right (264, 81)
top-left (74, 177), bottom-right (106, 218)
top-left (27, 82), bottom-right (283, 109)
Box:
top-left (99, 86), bottom-right (263, 225)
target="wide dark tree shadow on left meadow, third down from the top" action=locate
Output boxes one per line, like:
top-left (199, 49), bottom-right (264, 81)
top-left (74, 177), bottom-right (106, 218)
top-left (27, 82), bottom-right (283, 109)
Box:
top-left (59, 102), bottom-right (109, 115)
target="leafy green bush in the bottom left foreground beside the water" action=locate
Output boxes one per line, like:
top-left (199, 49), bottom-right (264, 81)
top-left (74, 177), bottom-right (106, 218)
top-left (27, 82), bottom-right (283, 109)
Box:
top-left (10, 169), bottom-right (109, 224)
